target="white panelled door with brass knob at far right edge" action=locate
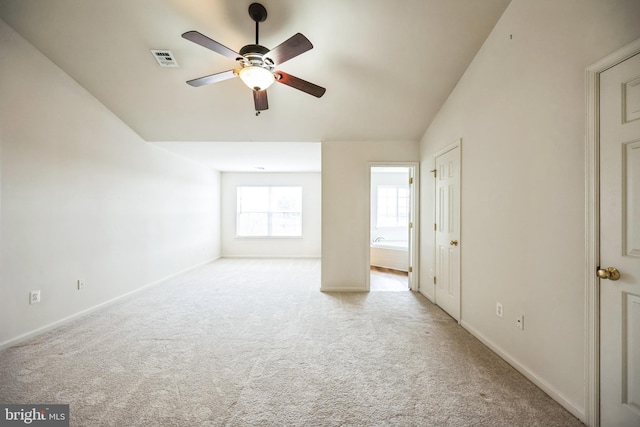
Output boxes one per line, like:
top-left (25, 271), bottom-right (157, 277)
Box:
top-left (598, 54), bottom-right (640, 426)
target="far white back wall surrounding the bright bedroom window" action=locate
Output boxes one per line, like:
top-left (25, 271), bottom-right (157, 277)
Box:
top-left (222, 172), bottom-right (322, 258)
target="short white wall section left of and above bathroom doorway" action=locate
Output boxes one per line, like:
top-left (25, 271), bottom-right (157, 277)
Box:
top-left (321, 141), bottom-right (419, 291)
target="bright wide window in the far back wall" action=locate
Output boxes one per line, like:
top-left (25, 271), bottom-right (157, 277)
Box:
top-left (236, 187), bottom-right (302, 237)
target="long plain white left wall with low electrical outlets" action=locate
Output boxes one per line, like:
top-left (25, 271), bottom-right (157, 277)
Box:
top-left (0, 20), bottom-right (220, 346)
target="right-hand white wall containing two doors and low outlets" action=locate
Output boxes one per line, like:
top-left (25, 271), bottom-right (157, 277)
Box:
top-left (420, 0), bottom-right (640, 419)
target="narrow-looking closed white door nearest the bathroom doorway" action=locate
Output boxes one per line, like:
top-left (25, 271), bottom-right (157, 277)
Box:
top-left (435, 144), bottom-right (460, 321)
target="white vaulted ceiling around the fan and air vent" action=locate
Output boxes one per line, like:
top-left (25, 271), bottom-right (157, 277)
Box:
top-left (0, 0), bottom-right (509, 170)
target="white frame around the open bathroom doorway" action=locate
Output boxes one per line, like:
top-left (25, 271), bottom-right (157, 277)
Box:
top-left (365, 162), bottom-right (420, 292)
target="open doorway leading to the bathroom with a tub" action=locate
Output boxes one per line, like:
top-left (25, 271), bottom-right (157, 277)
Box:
top-left (367, 163), bottom-right (418, 291)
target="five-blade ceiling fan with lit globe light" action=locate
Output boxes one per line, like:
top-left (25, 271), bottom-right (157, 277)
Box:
top-left (182, 3), bottom-right (326, 116)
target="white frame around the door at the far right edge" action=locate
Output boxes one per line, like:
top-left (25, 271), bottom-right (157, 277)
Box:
top-left (584, 39), bottom-right (640, 427)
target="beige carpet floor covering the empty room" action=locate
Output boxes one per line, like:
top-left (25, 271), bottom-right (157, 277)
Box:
top-left (0, 259), bottom-right (581, 426)
